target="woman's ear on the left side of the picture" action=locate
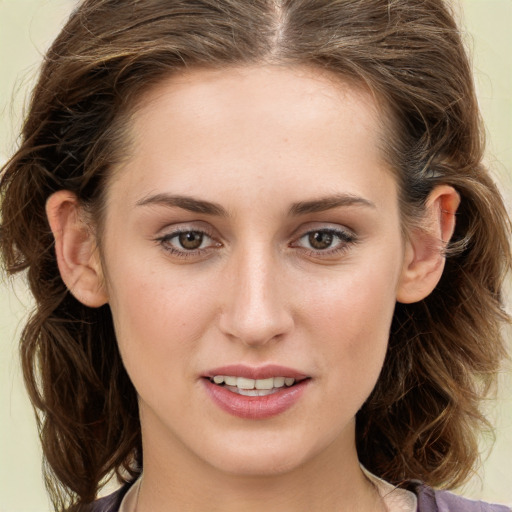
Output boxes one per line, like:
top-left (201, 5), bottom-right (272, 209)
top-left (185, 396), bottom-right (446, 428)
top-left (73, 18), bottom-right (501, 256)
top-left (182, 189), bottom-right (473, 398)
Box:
top-left (46, 190), bottom-right (108, 308)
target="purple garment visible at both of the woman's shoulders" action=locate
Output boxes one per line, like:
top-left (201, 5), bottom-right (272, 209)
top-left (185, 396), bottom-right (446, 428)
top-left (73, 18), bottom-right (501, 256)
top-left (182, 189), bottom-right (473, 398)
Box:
top-left (88, 481), bottom-right (511, 512)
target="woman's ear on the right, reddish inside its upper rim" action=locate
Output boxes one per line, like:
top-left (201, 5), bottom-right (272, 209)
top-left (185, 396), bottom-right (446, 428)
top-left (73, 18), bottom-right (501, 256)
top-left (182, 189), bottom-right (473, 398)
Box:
top-left (397, 185), bottom-right (460, 304)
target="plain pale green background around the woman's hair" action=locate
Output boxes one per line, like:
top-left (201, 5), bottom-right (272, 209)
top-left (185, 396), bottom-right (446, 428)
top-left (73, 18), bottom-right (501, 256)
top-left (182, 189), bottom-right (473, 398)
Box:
top-left (0, 0), bottom-right (512, 512)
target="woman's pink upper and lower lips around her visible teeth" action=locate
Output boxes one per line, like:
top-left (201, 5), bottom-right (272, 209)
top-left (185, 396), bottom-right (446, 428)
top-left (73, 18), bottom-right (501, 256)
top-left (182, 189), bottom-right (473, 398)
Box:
top-left (201, 365), bottom-right (311, 420)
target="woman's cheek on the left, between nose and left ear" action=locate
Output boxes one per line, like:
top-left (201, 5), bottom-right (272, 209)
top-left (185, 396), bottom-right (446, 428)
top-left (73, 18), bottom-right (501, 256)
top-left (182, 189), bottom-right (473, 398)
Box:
top-left (105, 266), bottom-right (212, 384)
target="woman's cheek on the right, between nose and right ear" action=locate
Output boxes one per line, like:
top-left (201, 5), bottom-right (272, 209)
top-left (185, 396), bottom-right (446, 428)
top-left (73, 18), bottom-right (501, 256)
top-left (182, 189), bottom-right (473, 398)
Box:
top-left (306, 251), bottom-right (399, 392)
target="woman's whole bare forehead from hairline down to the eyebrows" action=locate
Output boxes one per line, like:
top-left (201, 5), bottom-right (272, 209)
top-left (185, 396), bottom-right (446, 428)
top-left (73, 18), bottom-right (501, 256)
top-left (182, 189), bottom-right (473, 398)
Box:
top-left (107, 66), bottom-right (396, 212)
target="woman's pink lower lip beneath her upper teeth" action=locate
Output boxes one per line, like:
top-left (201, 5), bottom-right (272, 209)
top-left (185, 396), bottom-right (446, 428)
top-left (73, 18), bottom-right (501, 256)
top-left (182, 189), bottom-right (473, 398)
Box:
top-left (203, 379), bottom-right (310, 420)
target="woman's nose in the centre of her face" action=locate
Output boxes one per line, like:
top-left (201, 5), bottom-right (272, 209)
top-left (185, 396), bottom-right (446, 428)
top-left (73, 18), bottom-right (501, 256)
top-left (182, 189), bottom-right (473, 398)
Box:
top-left (219, 245), bottom-right (294, 347)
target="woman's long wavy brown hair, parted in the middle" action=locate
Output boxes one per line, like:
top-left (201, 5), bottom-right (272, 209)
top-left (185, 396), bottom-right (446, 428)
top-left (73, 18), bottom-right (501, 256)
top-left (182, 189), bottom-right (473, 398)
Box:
top-left (0, 0), bottom-right (510, 509)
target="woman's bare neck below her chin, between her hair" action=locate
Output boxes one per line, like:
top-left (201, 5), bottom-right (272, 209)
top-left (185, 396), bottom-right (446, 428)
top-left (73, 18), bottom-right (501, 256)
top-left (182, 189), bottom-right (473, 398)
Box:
top-left (136, 420), bottom-right (383, 512)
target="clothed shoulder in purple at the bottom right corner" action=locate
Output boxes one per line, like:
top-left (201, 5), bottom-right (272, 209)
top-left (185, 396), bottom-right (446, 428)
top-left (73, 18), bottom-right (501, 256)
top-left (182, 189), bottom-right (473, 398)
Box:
top-left (407, 481), bottom-right (511, 512)
